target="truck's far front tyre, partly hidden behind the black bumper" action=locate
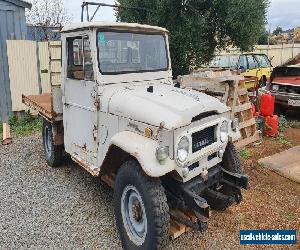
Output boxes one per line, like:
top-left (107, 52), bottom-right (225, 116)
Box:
top-left (205, 142), bottom-right (242, 211)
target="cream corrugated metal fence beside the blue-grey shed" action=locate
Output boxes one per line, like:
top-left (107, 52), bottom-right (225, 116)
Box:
top-left (7, 40), bottom-right (61, 111)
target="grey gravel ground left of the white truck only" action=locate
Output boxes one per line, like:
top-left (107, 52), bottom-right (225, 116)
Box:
top-left (0, 137), bottom-right (120, 249)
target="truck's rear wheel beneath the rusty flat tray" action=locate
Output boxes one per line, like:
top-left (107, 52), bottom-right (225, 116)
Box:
top-left (43, 120), bottom-right (64, 167)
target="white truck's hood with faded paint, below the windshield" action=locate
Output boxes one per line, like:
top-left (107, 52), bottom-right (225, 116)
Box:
top-left (108, 84), bottom-right (229, 129)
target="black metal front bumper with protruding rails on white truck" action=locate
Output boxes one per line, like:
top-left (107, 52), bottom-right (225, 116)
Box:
top-left (162, 165), bottom-right (248, 230)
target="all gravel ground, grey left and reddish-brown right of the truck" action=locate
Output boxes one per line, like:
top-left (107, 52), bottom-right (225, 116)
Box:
top-left (0, 136), bottom-right (300, 249)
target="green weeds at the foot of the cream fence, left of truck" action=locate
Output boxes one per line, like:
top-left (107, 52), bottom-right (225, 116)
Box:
top-left (0, 113), bottom-right (43, 140)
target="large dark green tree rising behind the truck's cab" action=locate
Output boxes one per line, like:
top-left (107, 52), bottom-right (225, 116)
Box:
top-left (117, 0), bottom-right (268, 76)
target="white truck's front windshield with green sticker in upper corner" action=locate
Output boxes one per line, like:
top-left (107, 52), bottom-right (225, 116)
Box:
top-left (97, 31), bottom-right (168, 74)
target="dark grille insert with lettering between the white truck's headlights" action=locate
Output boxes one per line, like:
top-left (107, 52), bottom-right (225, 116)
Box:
top-left (192, 126), bottom-right (216, 153)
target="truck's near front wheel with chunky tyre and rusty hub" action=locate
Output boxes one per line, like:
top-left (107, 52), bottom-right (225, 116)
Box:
top-left (114, 160), bottom-right (170, 250)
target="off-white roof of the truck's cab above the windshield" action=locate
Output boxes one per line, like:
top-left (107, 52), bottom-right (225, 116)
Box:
top-left (61, 22), bottom-right (168, 33)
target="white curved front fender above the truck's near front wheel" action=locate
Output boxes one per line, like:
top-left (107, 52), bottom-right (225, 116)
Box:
top-left (111, 131), bottom-right (176, 177)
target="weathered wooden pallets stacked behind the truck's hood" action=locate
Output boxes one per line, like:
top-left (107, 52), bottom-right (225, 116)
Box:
top-left (177, 69), bottom-right (260, 148)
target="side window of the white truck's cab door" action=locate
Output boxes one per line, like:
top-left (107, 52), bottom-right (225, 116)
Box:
top-left (67, 37), bottom-right (94, 81)
